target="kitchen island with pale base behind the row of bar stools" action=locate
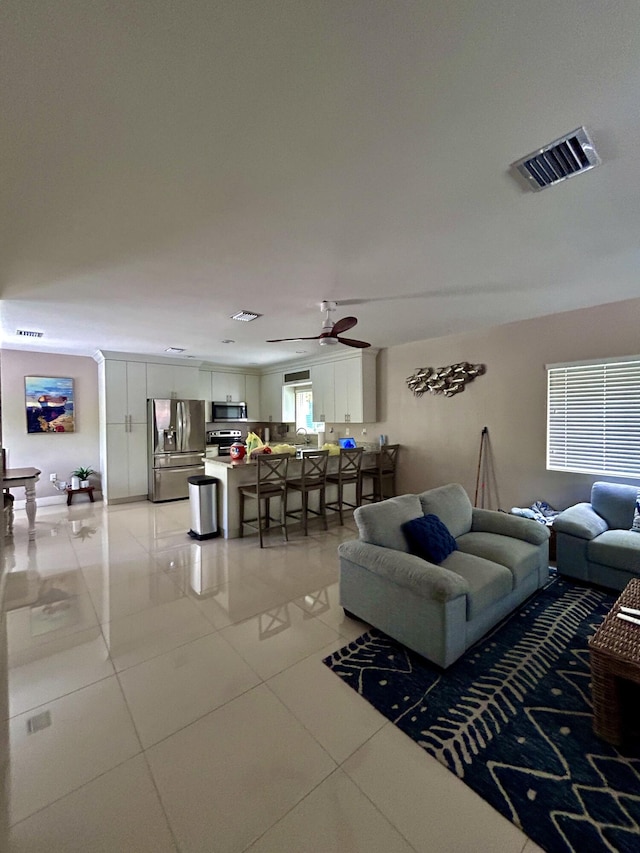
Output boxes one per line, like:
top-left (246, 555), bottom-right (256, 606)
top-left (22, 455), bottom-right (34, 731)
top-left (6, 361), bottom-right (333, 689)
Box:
top-left (204, 450), bottom-right (378, 539)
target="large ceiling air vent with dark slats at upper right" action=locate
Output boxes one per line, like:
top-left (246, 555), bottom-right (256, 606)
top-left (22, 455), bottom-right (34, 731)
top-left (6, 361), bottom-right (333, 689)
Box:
top-left (511, 127), bottom-right (602, 192)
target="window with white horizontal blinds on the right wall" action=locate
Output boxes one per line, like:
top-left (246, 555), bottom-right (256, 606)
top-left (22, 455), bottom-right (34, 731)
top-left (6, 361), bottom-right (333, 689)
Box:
top-left (547, 356), bottom-right (640, 478)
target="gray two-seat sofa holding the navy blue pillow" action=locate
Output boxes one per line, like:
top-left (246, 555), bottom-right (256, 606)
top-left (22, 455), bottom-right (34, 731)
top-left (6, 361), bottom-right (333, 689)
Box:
top-left (338, 484), bottom-right (552, 667)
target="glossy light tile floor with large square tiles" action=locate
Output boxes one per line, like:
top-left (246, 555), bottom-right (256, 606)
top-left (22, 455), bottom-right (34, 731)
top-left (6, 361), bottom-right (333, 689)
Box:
top-left (0, 501), bottom-right (539, 853)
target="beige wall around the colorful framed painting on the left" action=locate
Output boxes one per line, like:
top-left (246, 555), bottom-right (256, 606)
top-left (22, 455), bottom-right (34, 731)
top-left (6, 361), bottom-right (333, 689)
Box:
top-left (1, 350), bottom-right (100, 502)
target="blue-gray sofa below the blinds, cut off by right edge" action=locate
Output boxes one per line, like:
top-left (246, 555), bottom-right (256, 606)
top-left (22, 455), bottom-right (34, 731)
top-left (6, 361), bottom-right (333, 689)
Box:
top-left (553, 483), bottom-right (640, 590)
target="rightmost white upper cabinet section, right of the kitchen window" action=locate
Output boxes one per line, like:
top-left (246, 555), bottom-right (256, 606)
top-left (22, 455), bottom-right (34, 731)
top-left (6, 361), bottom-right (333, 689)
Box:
top-left (332, 353), bottom-right (376, 424)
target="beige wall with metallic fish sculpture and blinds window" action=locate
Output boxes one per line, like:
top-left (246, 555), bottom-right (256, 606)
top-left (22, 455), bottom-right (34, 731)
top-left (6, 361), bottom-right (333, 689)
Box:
top-left (368, 299), bottom-right (640, 511)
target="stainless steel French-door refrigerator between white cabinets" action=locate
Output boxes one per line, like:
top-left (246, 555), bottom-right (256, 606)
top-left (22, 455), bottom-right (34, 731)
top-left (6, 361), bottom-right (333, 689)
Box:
top-left (148, 400), bottom-right (205, 502)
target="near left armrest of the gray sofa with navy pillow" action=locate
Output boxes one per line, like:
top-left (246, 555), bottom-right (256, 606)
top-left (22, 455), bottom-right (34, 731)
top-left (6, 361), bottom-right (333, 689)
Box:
top-left (338, 539), bottom-right (469, 601)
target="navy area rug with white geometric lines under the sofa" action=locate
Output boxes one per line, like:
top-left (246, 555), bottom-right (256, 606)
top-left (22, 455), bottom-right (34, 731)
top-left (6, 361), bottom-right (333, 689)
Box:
top-left (324, 580), bottom-right (640, 853)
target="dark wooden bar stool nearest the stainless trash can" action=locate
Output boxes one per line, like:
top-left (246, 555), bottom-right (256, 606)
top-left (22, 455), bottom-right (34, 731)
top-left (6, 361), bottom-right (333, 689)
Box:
top-left (238, 453), bottom-right (290, 548)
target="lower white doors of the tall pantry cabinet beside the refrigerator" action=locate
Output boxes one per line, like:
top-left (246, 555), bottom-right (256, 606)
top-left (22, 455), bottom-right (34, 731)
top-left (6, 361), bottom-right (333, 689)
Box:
top-left (102, 423), bottom-right (148, 501)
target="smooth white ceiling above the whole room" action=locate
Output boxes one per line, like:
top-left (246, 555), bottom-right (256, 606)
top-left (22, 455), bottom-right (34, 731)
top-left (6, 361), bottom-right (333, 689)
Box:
top-left (0, 0), bottom-right (640, 365)
